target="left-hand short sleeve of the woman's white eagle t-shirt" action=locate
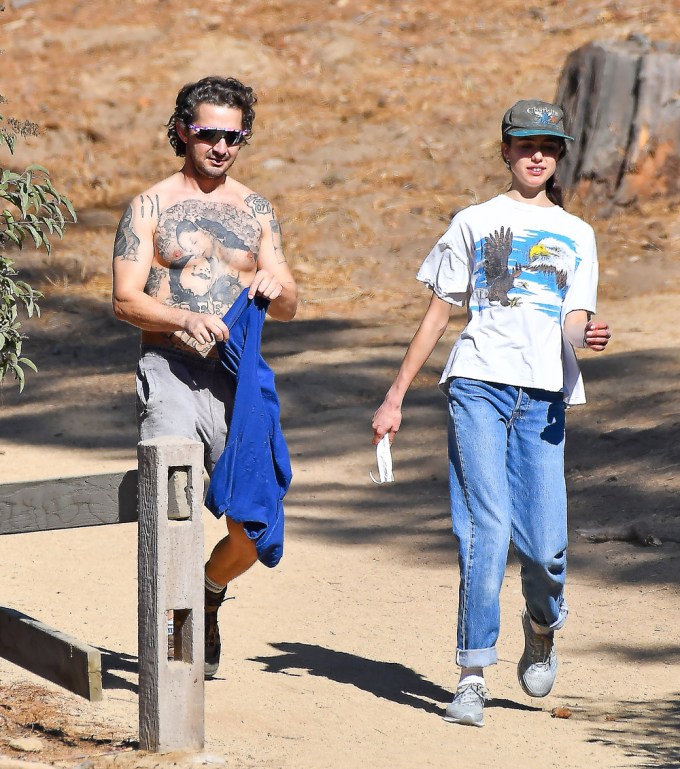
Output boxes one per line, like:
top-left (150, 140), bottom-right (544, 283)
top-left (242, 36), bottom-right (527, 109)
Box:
top-left (416, 217), bottom-right (471, 307)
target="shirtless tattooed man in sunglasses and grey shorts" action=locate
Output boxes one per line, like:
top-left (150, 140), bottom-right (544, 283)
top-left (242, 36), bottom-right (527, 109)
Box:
top-left (113, 77), bottom-right (297, 677)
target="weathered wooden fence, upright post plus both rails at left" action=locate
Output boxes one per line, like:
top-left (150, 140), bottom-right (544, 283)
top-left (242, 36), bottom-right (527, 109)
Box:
top-left (0, 436), bottom-right (204, 751)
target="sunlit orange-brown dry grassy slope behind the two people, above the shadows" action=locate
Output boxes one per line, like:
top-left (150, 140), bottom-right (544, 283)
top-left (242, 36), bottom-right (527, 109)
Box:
top-left (0, 0), bottom-right (680, 317)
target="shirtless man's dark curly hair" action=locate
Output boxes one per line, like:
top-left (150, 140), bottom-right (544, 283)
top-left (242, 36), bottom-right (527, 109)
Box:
top-left (166, 75), bottom-right (257, 158)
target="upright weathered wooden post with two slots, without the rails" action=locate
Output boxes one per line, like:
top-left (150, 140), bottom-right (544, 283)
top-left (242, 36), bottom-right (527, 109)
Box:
top-left (138, 436), bottom-right (204, 751)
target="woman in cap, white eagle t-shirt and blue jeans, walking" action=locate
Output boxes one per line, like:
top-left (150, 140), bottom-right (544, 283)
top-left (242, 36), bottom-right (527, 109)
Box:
top-left (373, 100), bottom-right (611, 726)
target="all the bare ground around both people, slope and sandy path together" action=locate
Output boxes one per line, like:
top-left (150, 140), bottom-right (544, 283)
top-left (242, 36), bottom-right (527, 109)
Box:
top-left (0, 0), bottom-right (680, 769)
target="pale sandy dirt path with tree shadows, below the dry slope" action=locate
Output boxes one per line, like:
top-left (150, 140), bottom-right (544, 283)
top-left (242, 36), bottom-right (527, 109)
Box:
top-left (0, 296), bottom-right (680, 769)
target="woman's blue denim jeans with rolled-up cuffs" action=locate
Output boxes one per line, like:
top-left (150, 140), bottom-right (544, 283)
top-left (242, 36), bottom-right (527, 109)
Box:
top-left (449, 377), bottom-right (568, 667)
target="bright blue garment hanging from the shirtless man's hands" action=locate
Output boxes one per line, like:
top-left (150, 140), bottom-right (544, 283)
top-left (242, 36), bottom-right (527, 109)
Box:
top-left (205, 288), bottom-right (292, 567)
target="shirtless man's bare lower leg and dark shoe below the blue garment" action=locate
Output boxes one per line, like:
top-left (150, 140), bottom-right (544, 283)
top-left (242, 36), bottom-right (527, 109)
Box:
top-left (205, 518), bottom-right (257, 678)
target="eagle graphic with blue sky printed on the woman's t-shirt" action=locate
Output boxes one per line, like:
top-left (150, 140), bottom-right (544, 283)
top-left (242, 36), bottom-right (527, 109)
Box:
top-left (471, 227), bottom-right (580, 317)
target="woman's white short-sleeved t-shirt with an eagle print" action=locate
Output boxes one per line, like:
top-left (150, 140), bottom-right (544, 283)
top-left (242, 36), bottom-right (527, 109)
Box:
top-left (417, 195), bottom-right (598, 404)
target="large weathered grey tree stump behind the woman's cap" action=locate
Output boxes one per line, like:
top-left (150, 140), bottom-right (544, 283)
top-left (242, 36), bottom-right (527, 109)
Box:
top-left (555, 35), bottom-right (680, 216)
